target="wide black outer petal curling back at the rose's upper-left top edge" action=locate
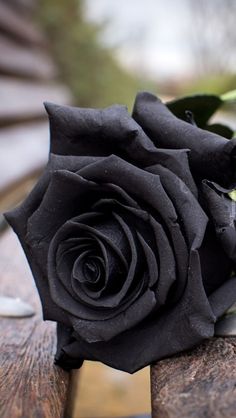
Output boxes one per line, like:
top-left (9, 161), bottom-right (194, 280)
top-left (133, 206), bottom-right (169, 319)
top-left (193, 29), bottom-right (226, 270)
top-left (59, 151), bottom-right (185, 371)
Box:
top-left (45, 103), bottom-right (158, 162)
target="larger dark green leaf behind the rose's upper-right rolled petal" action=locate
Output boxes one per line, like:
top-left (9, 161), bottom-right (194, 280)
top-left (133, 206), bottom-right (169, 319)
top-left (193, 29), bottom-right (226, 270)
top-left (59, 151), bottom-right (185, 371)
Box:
top-left (166, 94), bottom-right (224, 128)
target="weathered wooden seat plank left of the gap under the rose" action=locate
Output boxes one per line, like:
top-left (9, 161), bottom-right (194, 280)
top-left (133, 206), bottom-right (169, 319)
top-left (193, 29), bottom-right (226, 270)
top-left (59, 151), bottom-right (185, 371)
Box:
top-left (0, 230), bottom-right (69, 418)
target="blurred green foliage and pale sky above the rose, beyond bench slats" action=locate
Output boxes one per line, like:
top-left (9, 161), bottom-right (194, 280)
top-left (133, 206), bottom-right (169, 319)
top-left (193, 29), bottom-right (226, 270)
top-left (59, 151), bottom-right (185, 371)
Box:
top-left (40, 0), bottom-right (236, 106)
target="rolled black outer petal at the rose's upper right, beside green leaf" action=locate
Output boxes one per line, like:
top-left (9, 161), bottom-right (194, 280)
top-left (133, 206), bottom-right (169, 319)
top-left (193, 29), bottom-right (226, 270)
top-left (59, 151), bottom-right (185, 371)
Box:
top-left (133, 93), bottom-right (236, 185)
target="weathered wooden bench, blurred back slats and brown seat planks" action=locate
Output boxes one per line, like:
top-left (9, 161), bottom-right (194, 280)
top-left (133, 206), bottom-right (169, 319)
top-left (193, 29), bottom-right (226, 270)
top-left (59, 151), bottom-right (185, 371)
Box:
top-left (0, 0), bottom-right (236, 418)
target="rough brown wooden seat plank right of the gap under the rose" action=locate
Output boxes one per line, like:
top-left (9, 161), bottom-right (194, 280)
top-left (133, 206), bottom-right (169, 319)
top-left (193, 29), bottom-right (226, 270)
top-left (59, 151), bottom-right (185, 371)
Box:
top-left (151, 337), bottom-right (236, 418)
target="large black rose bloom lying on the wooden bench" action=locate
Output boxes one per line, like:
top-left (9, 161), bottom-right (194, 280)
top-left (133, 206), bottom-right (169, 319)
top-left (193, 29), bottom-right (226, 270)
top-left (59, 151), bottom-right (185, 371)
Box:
top-left (6, 93), bottom-right (236, 372)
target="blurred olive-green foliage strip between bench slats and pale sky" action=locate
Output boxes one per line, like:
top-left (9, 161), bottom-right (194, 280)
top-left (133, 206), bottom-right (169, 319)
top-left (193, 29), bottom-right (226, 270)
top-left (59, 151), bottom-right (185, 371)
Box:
top-left (39, 0), bottom-right (154, 107)
